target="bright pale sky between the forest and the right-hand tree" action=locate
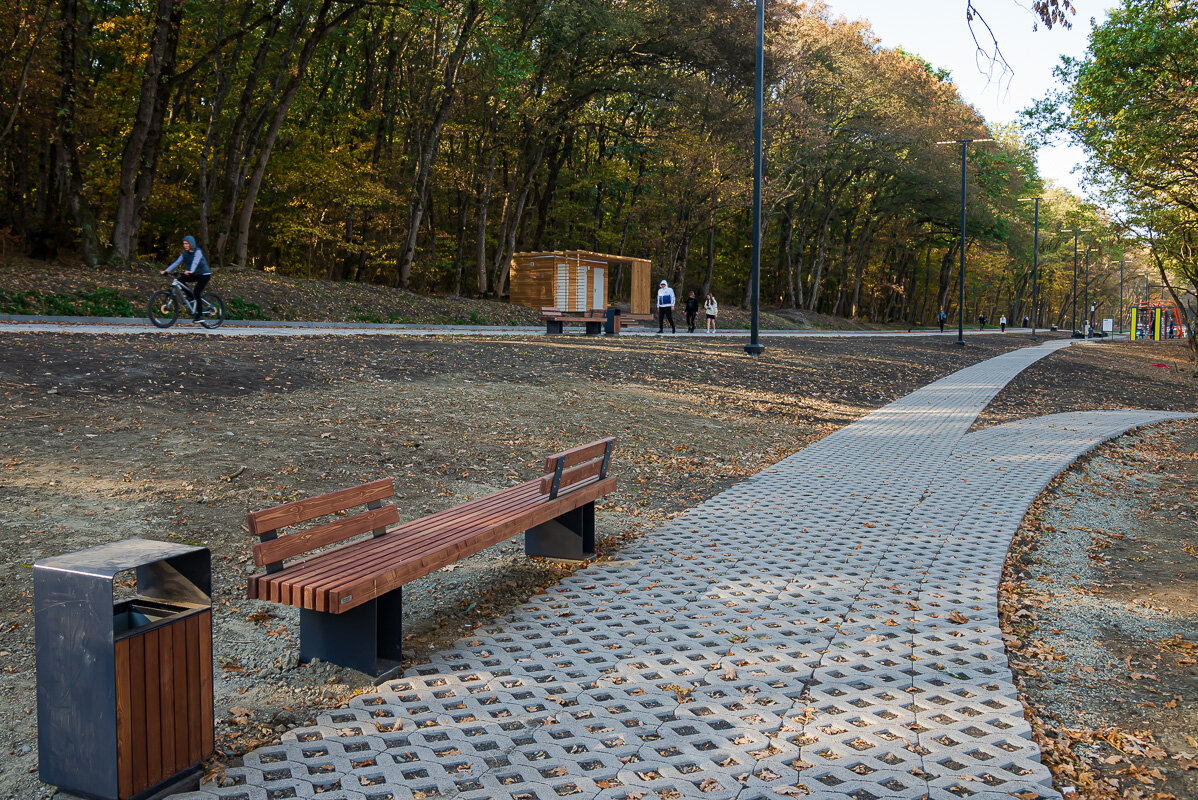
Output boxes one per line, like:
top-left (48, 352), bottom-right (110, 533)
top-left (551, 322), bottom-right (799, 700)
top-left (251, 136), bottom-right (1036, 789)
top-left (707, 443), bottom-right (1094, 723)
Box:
top-left (827, 0), bottom-right (1112, 194)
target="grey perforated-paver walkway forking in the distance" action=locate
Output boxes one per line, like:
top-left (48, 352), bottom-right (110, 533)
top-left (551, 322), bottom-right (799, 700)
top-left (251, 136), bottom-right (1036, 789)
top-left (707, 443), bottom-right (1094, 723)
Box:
top-left (171, 343), bottom-right (1181, 800)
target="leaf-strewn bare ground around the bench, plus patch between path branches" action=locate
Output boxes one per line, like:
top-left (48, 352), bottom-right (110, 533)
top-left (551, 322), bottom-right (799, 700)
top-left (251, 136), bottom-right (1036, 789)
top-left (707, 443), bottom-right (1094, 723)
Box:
top-left (0, 334), bottom-right (1198, 800)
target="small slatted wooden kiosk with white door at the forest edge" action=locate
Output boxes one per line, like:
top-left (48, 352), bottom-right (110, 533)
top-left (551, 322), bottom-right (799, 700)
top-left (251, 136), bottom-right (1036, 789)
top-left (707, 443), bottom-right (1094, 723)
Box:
top-left (510, 250), bottom-right (653, 314)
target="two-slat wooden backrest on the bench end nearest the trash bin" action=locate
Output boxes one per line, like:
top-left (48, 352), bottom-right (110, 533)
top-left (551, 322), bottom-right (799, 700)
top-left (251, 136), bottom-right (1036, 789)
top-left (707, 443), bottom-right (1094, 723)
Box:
top-left (246, 478), bottom-right (399, 572)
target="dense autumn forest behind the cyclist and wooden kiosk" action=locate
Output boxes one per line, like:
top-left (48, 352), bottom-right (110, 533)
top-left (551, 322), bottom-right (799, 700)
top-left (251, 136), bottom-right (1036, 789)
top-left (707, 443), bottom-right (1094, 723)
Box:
top-left (0, 0), bottom-right (1123, 325)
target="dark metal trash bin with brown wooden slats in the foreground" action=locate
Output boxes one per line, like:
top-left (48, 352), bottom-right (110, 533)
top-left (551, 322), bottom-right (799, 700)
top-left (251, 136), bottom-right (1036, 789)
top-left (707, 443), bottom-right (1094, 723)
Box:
top-left (34, 539), bottom-right (214, 800)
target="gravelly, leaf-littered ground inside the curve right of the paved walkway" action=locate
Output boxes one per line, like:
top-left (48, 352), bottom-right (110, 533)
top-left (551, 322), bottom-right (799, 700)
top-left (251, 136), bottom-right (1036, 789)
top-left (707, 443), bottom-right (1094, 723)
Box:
top-left (1002, 420), bottom-right (1198, 800)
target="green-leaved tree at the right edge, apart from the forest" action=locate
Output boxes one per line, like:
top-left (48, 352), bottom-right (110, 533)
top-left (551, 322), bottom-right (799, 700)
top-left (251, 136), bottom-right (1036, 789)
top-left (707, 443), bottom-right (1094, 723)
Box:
top-left (1030, 0), bottom-right (1198, 358)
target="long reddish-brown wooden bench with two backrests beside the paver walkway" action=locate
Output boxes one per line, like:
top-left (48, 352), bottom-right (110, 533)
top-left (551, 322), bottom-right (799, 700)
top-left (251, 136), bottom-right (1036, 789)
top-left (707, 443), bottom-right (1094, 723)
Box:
top-left (246, 438), bottom-right (616, 675)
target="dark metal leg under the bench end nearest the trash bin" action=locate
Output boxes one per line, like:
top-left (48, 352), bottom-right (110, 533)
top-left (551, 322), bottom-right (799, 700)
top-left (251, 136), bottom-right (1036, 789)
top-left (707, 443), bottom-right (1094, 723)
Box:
top-left (300, 588), bottom-right (404, 677)
